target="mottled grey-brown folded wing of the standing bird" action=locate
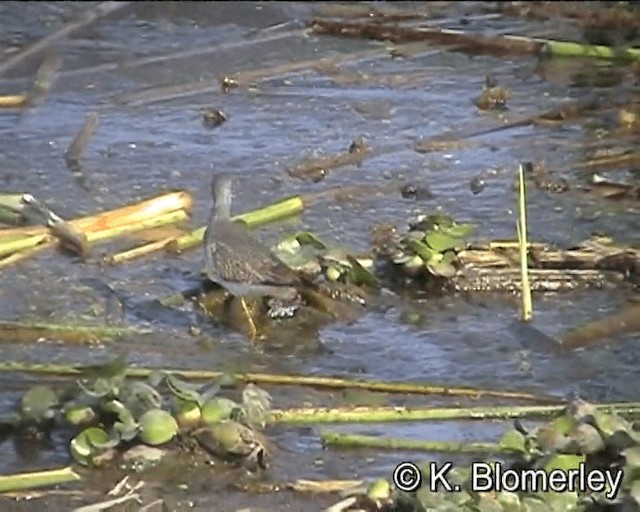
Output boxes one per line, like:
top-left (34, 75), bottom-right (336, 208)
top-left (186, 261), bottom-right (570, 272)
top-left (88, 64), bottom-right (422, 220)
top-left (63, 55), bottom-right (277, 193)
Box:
top-left (209, 222), bottom-right (301, 286)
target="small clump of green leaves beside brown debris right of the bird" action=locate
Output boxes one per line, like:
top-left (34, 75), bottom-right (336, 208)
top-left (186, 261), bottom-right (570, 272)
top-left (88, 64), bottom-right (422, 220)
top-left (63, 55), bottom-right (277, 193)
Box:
top-left (393, 214), bottom-right (474, 278)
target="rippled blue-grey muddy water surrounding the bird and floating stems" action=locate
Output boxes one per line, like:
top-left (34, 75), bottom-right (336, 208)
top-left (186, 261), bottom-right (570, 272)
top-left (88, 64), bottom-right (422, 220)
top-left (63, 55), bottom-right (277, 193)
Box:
top-left (0, 2), bottom-right (640, 510)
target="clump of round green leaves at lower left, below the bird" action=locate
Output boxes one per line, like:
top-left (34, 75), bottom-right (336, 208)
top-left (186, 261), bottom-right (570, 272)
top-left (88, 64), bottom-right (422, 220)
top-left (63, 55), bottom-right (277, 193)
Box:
top-left (0, 361), bottom-right (271, 472)
